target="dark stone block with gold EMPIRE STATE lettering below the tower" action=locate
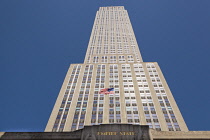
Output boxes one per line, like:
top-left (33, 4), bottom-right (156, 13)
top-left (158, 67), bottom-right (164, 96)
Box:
top-left (81, 124), bottom-right (150, 140)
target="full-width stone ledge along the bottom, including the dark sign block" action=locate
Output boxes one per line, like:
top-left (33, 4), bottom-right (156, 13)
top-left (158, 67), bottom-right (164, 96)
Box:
top-left (0, 124), bottom-right (210, 140)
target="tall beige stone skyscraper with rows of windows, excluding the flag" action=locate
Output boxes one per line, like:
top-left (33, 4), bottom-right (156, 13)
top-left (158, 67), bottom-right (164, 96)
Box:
top-left (45, 6), bottom-right (188, 132)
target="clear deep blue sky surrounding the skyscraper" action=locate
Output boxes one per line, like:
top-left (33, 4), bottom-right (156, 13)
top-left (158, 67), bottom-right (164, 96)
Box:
top-left (0, 0), bottom-right (210, 132)
